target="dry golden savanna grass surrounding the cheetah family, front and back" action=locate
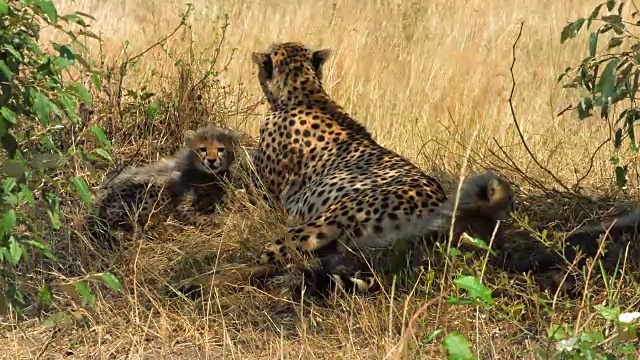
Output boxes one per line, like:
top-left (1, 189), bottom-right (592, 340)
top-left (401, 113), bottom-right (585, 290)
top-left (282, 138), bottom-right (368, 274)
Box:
top-left (0, 0), bottom-right (638, 359)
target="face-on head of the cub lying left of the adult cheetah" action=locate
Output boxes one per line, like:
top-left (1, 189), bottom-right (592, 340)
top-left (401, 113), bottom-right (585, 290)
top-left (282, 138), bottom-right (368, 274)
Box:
top-left (184, 126), bottom-right (239, 173)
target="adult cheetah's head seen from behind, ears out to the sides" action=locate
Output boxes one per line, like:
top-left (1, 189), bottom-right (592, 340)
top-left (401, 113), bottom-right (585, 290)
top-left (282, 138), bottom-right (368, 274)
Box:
top-left (251, 42), bottom-right (331, 108)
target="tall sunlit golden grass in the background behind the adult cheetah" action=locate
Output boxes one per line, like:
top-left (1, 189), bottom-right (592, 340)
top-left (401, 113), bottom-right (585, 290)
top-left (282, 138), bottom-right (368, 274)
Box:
top-left (57, 0), bottom-right (612, 185)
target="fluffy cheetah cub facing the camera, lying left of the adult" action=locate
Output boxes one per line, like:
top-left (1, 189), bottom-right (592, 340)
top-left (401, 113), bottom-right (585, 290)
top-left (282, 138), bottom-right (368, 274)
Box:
top-left (87, 126), bottom-right (238, 248)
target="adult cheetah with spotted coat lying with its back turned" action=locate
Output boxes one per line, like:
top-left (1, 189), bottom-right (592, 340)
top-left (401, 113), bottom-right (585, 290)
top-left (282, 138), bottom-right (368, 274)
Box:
top-left (183, 42), bottom-right (516, 291)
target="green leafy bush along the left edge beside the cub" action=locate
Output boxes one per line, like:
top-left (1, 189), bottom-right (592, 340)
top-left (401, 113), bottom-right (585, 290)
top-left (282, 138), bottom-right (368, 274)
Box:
top-left (0, 0), bottom-right (119, 315)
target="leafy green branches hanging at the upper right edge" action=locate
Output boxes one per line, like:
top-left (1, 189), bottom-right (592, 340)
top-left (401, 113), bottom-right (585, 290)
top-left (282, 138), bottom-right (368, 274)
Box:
top-left (558, 0), bottom-right (640, 189)
